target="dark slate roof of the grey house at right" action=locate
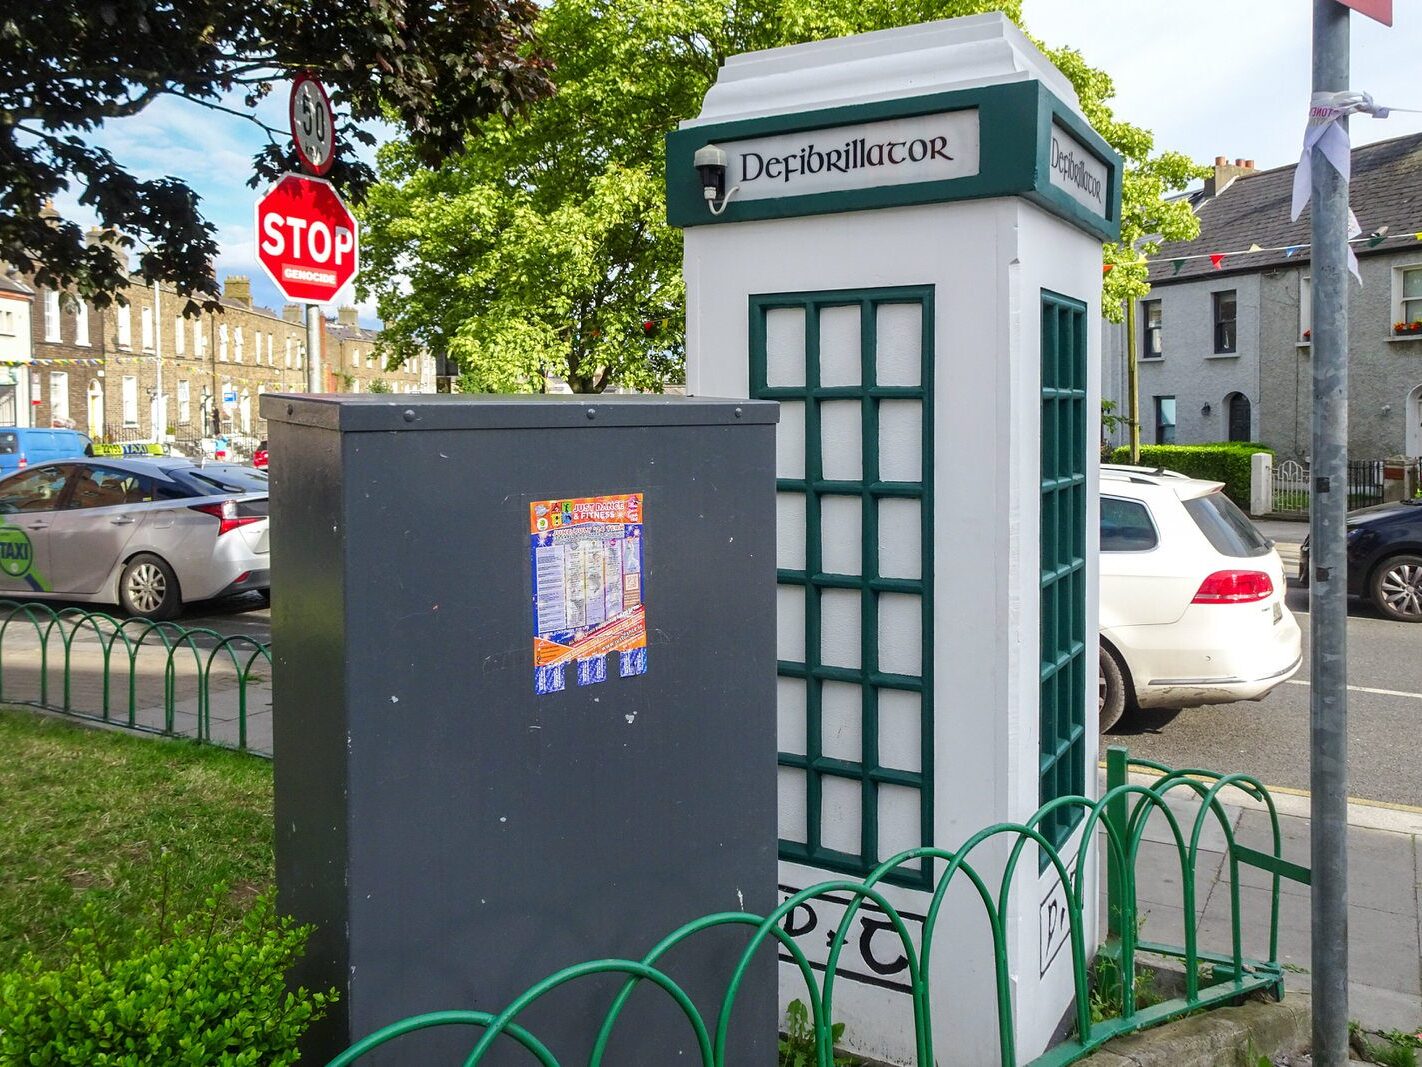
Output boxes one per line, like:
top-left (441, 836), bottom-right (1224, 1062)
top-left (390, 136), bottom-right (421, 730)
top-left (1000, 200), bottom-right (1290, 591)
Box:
top-left (1149, 130), bottom-right (1422, 285)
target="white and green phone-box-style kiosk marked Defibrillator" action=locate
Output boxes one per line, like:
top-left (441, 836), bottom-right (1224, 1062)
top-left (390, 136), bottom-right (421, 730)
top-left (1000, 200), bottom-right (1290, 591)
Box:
top-left (667, 14), bottom-right (1121, 1064)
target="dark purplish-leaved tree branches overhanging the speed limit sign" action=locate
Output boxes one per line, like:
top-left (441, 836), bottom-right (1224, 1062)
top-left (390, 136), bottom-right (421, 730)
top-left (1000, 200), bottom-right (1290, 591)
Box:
top-left (0, 0), bottom-right (552, 306)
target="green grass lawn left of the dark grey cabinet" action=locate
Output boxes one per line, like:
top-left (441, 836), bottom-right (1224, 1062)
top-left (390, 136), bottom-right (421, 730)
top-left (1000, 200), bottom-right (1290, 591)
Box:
top-left (0, 708), bottom-right (273, 970)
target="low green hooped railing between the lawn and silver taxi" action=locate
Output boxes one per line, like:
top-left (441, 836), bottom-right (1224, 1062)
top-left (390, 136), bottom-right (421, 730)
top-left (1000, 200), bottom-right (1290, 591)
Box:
top-left (0, 600), bottom-right (272, 754)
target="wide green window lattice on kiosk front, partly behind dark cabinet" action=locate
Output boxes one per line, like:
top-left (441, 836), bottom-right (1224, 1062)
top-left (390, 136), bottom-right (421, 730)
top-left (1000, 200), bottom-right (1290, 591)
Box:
top-left (749, 286), bottom-right (934, 888)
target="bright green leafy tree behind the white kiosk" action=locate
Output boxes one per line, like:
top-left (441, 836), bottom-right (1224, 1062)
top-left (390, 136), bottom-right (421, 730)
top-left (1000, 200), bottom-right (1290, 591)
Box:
top-left (361, 0), bottom-right (1194, 393)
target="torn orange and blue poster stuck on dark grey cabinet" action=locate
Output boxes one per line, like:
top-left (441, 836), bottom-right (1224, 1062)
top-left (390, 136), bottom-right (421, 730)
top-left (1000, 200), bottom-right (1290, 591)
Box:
top-left (529, 492), bottom-right (647, 694)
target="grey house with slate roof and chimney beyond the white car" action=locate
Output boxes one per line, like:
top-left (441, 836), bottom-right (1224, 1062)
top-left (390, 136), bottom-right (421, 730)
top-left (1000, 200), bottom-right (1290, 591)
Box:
top-left (1102, 135), bottom-right (1422, 460)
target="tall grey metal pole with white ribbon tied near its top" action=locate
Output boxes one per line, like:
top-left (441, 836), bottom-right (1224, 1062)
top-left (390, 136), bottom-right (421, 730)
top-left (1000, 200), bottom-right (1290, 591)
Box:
top-left (1308, 0), bottom-right (1348, 1067)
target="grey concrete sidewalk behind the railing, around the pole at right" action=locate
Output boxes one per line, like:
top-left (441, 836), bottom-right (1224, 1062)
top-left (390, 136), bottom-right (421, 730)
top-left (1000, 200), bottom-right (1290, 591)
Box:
top-left (1132, 775), bottom-right (1422, 1033)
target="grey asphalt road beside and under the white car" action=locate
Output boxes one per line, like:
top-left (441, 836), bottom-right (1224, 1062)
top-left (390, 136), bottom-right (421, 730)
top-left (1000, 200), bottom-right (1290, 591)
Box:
top-left (1108, 524), bottom-right (1422, 805)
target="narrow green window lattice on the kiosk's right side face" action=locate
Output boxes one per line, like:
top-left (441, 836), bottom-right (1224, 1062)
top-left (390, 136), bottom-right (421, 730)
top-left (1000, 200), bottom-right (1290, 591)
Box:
top-left (1038, 289), bottom-right (1095, 866)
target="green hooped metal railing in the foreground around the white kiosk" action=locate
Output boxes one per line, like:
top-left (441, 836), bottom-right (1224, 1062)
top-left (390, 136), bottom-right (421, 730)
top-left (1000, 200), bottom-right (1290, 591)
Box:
top-left (328, 748), bottom-right (1310, 1067)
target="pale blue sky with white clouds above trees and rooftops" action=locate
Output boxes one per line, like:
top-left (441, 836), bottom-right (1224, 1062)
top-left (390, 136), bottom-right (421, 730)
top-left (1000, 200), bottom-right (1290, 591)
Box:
top-left (55, 0), bottom-right (1422, 326)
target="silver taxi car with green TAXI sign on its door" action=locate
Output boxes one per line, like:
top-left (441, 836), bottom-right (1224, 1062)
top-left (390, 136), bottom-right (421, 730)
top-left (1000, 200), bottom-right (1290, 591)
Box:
top-left (0, 457), bottom-right (270, 619)
